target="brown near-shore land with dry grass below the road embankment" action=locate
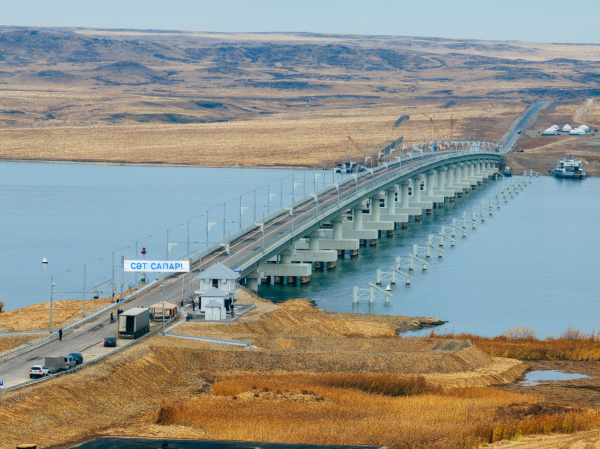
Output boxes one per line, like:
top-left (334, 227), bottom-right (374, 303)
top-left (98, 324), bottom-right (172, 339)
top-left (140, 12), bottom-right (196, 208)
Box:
top-left (0, 292), bottom-right (600, 449)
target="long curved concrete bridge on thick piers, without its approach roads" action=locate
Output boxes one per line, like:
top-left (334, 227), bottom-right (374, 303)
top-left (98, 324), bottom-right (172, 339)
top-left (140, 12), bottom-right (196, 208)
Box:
top-left (192, 142), bottom-right (502, 290)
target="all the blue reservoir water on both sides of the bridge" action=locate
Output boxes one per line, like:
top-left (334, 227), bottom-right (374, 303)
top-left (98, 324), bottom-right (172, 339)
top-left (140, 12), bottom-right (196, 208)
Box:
top-left (0, 162), bottom-right (600, 337)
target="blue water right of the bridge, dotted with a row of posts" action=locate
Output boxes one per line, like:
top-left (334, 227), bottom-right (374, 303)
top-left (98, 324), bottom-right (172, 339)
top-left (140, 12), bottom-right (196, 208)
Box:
top-left (259, 177), bottom-right (600, 337)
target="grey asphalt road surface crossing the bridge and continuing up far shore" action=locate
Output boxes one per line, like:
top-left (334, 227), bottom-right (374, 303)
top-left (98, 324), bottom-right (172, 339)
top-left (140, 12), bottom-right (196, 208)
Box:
top-left (0, 102), bottom-right (548, 387)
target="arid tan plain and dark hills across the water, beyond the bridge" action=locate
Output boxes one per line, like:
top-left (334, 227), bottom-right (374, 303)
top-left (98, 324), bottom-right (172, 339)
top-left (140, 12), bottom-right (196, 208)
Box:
top-left (0, 27), bottom-right (600, 169)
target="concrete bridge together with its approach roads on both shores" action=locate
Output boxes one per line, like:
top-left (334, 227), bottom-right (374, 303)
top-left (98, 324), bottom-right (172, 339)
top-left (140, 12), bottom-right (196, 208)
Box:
top-left (0, 102), bottom-right (545, 387)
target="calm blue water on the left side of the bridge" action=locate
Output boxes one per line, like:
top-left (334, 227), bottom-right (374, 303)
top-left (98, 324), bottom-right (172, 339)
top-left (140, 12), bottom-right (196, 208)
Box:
top-left (0, 162), bottom-right (332, 310)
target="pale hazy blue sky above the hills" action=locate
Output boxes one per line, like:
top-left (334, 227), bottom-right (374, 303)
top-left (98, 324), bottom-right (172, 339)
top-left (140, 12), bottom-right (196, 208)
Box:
top-left (0, 0), bottom-right (600, 44)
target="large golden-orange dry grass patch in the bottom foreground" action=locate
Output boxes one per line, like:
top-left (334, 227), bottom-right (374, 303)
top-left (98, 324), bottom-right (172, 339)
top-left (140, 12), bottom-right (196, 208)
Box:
top-left (157, 373), bottom-right (600, 448)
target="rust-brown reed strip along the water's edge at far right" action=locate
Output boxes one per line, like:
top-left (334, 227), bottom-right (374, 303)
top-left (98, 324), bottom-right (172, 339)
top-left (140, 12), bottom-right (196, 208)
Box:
top-left (430, 328), bottom-right (600, 361)
